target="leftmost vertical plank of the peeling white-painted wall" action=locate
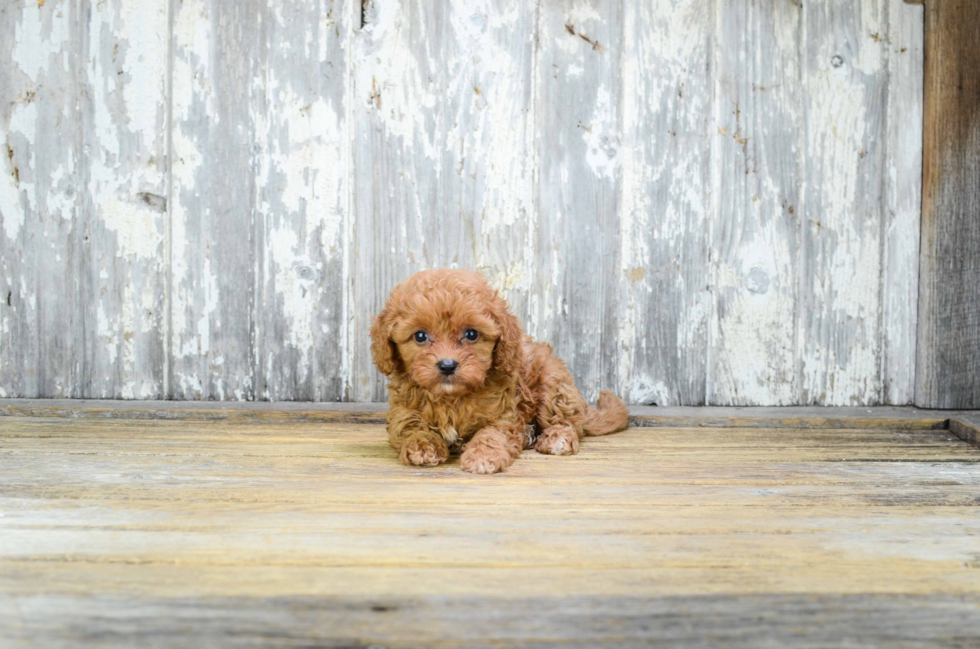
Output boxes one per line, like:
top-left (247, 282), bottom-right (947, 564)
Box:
top-left (0, 0), bottom-right (77, 397)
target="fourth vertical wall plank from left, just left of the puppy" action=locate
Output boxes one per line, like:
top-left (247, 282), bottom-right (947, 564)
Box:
top-left (253, 0), bottom-right (351, 401)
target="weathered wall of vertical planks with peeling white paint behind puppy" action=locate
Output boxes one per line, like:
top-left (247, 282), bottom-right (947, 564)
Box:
top-left (0, 0), bottom-right (923, 405)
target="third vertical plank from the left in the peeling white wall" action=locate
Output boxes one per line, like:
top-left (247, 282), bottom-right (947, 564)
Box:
top-left (169, 0), bottom-right (265, 400)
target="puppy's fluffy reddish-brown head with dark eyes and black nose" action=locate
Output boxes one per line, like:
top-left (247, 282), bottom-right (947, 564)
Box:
top-left (371, 269), bottom-right (523, 395)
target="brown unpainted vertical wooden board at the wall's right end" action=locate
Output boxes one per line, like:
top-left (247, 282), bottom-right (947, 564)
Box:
top-left (915, 0), bottom-right (980, 408)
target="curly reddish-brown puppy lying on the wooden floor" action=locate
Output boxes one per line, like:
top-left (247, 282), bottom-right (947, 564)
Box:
top-left (371, 269), bottom-right (629, 473)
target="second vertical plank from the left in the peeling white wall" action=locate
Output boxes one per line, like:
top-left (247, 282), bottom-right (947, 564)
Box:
top-left (73, 0), bottom-right (170, 399)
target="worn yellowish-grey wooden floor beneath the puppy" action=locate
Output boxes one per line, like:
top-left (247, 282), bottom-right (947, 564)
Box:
top-left (0, 416), bottom-right (980, 649)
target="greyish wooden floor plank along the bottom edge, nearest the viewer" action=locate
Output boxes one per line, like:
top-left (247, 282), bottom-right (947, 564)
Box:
top-left (0, 592), bottom-right (980, 649)
